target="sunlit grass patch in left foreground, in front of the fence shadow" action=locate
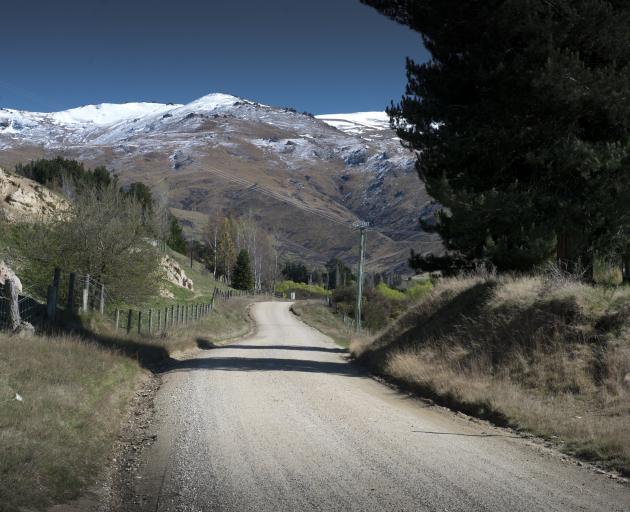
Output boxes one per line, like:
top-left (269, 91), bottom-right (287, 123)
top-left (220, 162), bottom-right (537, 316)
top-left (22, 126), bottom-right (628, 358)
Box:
top-left (0, 335), bottom-right (142, 511)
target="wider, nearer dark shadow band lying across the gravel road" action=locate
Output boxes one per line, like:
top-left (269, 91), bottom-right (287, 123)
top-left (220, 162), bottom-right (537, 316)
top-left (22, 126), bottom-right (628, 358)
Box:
top-left (168, 357), bottom-right (364, 377)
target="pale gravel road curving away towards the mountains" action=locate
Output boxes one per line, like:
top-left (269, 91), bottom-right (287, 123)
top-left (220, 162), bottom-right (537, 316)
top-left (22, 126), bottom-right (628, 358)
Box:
top-left (128, 302), bottom-right (630, 512)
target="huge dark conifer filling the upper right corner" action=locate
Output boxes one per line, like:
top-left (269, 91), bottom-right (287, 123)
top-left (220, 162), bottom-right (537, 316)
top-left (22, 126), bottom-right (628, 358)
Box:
top-left (363, 0), bottom-right (630, 269)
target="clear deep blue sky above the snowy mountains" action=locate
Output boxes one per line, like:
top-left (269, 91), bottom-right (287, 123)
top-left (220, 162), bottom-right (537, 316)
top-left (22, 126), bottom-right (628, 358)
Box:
top-left (0, 0), bottom-right (427, 114)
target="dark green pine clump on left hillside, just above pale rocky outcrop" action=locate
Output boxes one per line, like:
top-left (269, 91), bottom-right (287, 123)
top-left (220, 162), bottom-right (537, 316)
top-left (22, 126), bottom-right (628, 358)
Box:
top-left (15, 157), bottom-right (117, 194)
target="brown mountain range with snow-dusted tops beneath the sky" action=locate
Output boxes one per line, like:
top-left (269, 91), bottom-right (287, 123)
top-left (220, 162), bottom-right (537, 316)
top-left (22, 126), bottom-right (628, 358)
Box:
top-left (0, 94), bottom-right (435, 267)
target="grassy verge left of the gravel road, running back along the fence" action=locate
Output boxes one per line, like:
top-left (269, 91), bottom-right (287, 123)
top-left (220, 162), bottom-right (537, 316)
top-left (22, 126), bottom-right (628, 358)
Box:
top-left (0, 255), bottom-right (251, 511)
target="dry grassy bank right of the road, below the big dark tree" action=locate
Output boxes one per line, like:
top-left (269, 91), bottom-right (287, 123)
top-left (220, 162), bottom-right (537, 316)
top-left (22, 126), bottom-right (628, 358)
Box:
top-left (351, 276), bottom-right (630, 474)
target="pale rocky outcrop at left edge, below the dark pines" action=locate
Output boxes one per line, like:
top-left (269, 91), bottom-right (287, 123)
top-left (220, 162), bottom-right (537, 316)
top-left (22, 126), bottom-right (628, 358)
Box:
top-left (0, 169), bottom-right (69, 223)
